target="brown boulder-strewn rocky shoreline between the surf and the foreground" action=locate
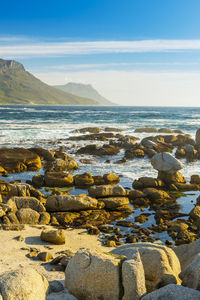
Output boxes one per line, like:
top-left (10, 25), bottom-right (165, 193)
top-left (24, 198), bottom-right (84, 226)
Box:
top-left (0, 127), bottom-right (200, 300)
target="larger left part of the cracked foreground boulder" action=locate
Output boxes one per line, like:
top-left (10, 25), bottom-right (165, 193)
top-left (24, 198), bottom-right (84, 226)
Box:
top-left (65, 250), bottom-right (122, 300)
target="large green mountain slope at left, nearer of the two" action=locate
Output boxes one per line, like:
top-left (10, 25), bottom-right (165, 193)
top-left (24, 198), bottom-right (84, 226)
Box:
top-left (0, 59), bottom-right (99, 105)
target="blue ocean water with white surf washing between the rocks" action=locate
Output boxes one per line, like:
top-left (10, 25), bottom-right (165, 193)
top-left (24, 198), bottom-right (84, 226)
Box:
top-left (0, 106), bottom-right (200, 244)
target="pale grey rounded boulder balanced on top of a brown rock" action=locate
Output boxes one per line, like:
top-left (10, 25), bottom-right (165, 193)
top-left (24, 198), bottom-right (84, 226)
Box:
top-left (151, 152), bottom-right (184, 173)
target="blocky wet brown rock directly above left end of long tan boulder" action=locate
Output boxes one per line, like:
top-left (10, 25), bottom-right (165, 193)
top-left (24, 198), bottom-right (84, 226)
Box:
top-left (44, 172), bottom-right (74, 187)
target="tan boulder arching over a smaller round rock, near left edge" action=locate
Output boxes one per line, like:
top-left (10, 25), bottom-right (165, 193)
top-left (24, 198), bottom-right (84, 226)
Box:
top-left (7, 197), bottom-right (46, 212)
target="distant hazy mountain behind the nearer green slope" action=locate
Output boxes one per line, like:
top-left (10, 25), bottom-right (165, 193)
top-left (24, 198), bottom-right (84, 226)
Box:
top-left (55, 82), bottom-right (115, 105)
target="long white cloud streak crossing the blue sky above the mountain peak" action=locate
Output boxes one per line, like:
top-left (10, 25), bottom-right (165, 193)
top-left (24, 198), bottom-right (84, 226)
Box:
top-left (0, 40), bottom-right (200, 58)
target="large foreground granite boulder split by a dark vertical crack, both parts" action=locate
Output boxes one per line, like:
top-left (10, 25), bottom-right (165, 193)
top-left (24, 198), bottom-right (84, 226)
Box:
top-left (65, 250), bottom-right (146, 300)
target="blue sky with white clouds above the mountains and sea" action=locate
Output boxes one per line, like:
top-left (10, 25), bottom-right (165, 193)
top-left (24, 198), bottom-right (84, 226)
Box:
top-left (0, 0), bottom-right (200, 106)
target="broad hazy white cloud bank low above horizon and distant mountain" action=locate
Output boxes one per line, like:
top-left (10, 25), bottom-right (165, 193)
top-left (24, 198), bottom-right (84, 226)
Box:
top-left (35, 70), bottom-right (200, 106)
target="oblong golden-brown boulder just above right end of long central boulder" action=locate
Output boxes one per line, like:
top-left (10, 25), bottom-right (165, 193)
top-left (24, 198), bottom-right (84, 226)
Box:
top-left (88, 184), bottom-right (126, 198)
